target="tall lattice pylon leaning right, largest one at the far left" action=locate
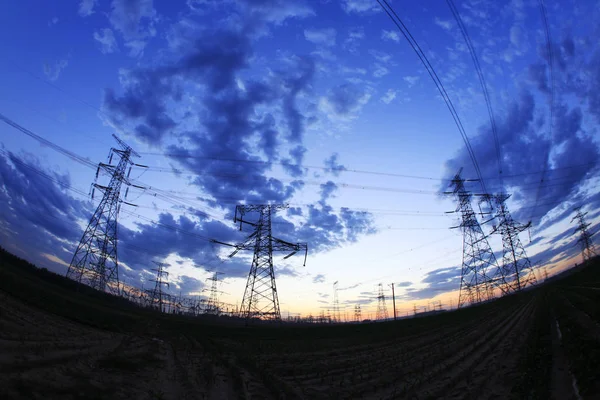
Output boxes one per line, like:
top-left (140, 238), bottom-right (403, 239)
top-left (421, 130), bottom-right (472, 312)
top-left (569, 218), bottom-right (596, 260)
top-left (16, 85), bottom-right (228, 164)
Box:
top-left (67, 135), bottom-right (146, 294)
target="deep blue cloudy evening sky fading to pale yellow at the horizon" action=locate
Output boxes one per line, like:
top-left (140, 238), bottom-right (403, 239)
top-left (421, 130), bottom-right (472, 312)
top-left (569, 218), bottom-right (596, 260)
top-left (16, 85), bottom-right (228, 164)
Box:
top-left (0, 0), bottom-right (600, 317)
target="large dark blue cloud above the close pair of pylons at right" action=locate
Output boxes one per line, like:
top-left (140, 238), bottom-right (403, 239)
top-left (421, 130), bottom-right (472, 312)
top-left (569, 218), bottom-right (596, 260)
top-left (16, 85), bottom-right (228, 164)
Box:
top-left (446, 90), bottom-right (600, 225)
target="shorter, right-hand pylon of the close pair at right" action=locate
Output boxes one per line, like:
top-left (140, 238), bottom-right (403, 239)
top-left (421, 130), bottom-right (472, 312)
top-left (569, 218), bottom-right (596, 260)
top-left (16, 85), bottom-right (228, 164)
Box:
top-left (492, 194), bottom-right (537, 294)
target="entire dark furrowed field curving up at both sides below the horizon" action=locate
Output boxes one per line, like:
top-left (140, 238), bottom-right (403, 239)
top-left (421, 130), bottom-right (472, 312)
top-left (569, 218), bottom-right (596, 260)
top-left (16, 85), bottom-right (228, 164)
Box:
top-left (0, 253), bottom-right (600, 399)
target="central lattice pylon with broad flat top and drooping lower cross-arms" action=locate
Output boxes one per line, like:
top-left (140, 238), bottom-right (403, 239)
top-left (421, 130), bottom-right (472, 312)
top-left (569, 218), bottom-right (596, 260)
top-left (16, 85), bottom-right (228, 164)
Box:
top-left (213, 204), bottom-right (308, 321)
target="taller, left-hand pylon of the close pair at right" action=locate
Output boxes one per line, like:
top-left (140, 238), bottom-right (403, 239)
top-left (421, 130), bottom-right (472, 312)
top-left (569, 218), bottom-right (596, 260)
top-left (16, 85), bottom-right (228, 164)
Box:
top-left (446, 169), bottom-right (502, 308)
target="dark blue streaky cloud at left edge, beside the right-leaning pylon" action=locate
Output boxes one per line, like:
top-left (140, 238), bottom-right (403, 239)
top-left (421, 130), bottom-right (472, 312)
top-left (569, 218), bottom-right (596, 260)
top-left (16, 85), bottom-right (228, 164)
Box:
top-left (0, 152), bottom-right (92, 274)
